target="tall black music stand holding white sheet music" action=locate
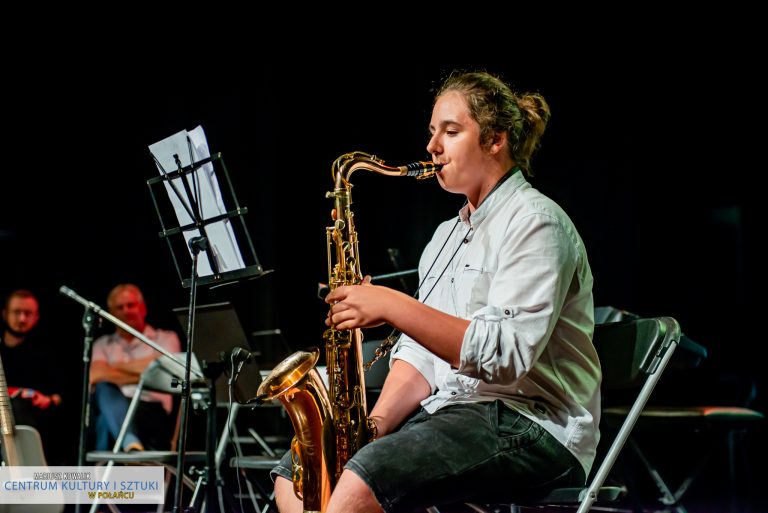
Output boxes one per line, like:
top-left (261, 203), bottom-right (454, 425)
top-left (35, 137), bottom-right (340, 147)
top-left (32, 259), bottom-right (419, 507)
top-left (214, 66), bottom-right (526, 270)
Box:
top-left (147, 126), bottom-right (271, 513)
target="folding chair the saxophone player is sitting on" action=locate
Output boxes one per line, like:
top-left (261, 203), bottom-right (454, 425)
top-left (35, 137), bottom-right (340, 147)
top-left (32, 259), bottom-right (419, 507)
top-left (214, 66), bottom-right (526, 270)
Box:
top-left (427, 317), bottom-right (680, 513)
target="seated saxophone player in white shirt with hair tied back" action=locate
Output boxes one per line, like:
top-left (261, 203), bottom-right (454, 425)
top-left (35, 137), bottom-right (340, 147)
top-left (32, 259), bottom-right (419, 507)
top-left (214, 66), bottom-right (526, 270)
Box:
top-left (273, 72), bottom-right (601, 513)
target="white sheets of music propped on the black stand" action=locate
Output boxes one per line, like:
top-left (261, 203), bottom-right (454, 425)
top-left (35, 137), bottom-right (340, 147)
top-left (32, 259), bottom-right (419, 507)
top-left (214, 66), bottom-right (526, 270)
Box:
top-left (149, 126), bottom-right (245, 276)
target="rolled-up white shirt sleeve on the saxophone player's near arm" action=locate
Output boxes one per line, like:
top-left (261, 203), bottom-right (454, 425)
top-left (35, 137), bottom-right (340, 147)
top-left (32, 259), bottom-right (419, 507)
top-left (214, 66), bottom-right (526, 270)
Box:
top-left (457, 214), bottom-right (577, 384)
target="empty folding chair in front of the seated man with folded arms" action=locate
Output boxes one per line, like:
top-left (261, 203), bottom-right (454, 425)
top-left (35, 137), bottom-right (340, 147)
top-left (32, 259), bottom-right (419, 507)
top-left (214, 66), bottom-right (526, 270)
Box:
top-left (85, 353), bottom-right (207, 513)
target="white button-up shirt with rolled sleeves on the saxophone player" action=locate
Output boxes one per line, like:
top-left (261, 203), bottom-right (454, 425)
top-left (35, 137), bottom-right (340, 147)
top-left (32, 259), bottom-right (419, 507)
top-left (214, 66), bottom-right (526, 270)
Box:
top-left (391, 172), bottom-right (601, 474)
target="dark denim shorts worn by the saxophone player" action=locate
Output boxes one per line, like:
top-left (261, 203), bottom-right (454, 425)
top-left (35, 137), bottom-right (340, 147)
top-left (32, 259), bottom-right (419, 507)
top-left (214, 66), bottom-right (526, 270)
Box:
top-left (272, 401), bottom-right (586, 512)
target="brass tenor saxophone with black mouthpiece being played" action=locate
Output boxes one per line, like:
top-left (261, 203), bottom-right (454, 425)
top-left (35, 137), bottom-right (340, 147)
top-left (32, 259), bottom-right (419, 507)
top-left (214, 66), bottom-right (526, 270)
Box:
top-left (257, 151), bottom-right (442, 512)
